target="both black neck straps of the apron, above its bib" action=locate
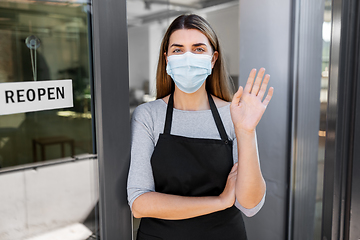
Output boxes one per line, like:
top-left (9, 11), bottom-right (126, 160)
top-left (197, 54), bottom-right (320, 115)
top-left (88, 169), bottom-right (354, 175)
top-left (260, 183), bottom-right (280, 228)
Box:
top-left (164, 93), bottom-right (228, 141)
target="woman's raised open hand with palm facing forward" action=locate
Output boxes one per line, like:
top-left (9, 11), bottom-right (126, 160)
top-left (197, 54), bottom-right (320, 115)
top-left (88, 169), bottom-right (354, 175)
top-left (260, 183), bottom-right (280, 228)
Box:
top-left (230, 68), bottom-right (274, 132)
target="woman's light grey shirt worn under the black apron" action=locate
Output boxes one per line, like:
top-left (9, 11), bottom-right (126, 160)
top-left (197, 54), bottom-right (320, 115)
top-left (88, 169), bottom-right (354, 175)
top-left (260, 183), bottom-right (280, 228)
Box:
top-left (127, 99), bottom-right (265, 217)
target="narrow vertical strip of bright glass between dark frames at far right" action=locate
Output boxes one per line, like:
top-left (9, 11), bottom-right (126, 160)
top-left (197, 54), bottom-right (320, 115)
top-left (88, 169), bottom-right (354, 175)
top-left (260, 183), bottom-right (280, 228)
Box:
top-left (314, 0), bottom-right (331, 239)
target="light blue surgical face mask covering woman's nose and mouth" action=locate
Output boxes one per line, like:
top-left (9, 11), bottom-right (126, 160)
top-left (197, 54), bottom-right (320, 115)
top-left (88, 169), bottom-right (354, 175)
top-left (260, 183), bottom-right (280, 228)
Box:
top-left (166, 52), bottom-right (212, 93)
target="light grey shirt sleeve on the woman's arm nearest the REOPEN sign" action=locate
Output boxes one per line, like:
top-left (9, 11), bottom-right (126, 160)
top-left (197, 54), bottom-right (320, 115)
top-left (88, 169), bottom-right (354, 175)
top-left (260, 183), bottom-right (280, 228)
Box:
top-left (127, 105), bottom-right (155, 208)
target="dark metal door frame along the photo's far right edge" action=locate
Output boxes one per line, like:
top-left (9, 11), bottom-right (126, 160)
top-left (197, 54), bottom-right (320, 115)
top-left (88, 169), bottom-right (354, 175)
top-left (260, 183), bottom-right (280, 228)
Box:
top-left (322, 0), bottom-right (360, 240)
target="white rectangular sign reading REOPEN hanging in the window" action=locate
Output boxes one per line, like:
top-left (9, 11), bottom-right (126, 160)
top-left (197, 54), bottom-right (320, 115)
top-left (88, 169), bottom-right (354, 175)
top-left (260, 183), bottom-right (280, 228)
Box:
top-left (0, 80), bottom-right (74, 115)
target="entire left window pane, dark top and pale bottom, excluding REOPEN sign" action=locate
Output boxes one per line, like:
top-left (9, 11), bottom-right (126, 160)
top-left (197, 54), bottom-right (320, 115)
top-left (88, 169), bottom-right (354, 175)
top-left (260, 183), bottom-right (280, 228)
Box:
top-left (0, 0), bottom-right (98, 240)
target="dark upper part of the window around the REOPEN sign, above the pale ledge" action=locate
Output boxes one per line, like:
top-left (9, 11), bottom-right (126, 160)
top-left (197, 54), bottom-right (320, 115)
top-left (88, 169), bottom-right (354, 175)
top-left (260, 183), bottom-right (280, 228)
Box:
top-left (0, 2), bottom-right (92, 168)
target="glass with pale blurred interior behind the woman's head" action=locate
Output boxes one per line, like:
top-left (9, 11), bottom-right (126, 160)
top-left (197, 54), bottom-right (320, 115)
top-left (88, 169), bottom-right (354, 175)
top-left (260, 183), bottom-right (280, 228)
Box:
top-left (127, 0), bottom-right (239, 236)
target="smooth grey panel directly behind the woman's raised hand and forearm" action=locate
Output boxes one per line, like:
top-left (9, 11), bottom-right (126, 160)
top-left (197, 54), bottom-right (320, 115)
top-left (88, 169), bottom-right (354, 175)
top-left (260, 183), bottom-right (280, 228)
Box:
top-left (239, 0), bottom-right (292, 240)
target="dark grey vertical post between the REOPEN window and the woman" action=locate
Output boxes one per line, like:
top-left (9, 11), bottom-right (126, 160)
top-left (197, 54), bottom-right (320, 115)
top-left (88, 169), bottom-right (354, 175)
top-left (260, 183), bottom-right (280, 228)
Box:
top-left (93, 0), bottom-right (132, 240)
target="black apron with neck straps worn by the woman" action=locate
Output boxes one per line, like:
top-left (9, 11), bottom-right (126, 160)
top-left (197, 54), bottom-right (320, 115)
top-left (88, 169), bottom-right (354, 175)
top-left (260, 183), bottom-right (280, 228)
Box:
top-left (137, 93), bottom-right (247, 240)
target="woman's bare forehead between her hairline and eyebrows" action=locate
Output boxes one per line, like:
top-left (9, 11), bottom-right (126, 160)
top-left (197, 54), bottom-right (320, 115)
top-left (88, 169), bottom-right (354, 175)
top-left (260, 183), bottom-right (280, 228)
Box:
top-left (169, 29), bottom-right (210, 47)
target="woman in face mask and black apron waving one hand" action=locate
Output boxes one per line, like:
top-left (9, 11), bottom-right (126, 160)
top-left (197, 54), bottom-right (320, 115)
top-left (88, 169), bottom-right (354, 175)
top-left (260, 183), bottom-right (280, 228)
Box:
top-left (128, 15), bottom-right (273, 240)
